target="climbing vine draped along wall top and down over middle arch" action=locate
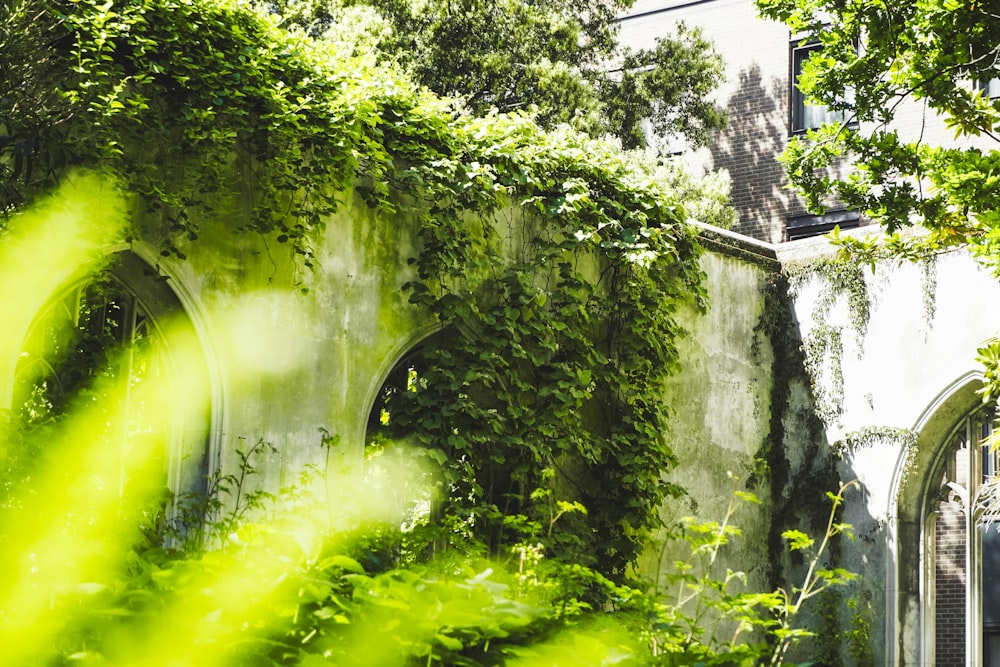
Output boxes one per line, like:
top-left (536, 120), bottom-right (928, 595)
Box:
top-left (0, 0), bottom-right (703, 578)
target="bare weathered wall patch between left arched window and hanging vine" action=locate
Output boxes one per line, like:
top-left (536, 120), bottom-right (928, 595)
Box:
top-left (144, 188), bottom-right (435, 496)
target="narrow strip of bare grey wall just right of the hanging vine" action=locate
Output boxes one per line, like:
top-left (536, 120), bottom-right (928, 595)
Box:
top-left (641, 232), bottom-right (778, 590)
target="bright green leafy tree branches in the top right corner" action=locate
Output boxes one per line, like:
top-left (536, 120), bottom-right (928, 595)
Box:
top-left (756, 0), bottom-right (1000, 271)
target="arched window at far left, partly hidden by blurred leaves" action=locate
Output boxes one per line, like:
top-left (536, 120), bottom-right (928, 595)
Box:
top-left (11, 252), bottom-right (210, 536)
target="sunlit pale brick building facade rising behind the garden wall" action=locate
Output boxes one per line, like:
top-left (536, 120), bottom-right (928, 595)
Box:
top-left (619, 0), bottom-right (989, 243)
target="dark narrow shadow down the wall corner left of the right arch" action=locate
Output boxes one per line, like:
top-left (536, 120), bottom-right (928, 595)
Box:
top-left (748, 274), bottom-right (882, 665)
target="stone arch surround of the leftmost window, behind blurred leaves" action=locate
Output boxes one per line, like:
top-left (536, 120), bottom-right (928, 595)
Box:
top-left (5, 247), bottom-right (219, 496)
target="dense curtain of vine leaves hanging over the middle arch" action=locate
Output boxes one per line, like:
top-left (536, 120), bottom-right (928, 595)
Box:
top-left (372, 118), bottom-right (701, 576)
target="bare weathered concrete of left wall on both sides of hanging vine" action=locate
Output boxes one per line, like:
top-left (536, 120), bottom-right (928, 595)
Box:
top-left (141, 201), bottom-right (848, 652)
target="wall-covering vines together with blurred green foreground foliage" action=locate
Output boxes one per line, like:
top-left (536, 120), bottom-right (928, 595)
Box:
top-left (0, 0), bottom-right (849, 665)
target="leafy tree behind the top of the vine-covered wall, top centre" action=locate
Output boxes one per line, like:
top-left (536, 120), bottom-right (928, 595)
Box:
top-left (263, 0), bottom-right (725, 148)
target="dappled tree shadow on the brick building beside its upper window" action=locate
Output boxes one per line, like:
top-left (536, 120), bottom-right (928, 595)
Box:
top-left (711, 64), bottom-right (789, 243)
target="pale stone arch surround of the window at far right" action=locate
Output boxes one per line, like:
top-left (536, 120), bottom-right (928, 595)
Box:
top-left (888, 371), bottom-right (982, 665)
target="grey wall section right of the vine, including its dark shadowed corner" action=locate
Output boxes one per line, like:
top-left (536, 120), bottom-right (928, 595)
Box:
top-left (642, 230), bottom-right (845, 664)
